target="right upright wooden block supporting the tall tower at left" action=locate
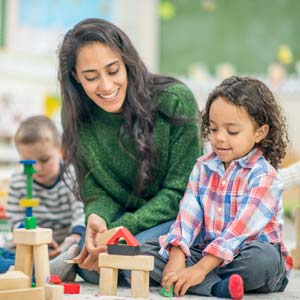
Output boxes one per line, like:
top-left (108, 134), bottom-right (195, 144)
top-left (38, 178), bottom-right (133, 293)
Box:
top-left (33, 244), bottom-right (50, 286)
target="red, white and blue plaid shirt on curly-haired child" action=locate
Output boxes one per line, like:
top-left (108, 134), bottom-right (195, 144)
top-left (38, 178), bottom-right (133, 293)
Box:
top-left (160, 149), bottom-right (292, 271)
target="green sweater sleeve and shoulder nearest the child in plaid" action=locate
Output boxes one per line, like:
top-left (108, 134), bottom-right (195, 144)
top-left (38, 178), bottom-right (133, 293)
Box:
top-left (111, 85), bottom-right (200, 234)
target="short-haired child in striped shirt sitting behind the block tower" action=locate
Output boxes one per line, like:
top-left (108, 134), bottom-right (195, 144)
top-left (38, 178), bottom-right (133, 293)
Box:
top-left (3, 116), bottom-right (85, 273)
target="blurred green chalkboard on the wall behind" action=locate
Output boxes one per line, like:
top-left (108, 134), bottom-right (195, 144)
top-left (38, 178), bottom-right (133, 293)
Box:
top-left (160, 0), bottom-right (300, 74)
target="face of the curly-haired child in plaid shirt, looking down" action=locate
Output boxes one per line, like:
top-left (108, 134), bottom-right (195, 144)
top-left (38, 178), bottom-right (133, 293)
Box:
top-left (209, 97), bottom-right (268, 168)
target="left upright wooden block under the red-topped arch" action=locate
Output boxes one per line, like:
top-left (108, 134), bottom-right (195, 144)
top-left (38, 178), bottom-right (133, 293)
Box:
top-left (99, 268), bottom-right (118, 296)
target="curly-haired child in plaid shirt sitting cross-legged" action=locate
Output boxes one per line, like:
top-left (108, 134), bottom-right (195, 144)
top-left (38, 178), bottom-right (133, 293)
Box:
top-left (142, 77), bottom-right (292, 299)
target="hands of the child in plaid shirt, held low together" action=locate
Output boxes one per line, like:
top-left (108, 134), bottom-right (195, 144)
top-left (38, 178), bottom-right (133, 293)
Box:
top-left (162, 265), bottom-right (206, 296)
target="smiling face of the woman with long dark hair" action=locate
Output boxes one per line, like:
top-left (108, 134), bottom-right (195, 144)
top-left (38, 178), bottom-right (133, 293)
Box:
top-left (75, 43), bottom-right (127, 113)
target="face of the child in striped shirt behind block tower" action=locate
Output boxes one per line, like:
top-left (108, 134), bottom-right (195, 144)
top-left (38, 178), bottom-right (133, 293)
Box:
top-left (17, 141), bottom-right (61, 186)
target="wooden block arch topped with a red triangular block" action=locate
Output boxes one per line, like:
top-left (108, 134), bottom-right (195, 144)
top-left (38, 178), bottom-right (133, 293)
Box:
top-left (98, 227), bottom-right (154, 298)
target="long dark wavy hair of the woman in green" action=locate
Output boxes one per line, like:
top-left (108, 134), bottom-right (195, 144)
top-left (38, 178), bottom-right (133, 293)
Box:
top-left (58, 19), bottom-right (179, 197)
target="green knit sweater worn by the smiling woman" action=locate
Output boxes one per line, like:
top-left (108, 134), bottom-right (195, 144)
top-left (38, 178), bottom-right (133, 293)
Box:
top-left (79, 84), bottom-right (201, 234)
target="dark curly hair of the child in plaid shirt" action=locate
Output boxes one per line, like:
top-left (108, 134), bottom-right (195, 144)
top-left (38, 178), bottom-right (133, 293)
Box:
top-left (201, 76), bottom-right (289, 169)
